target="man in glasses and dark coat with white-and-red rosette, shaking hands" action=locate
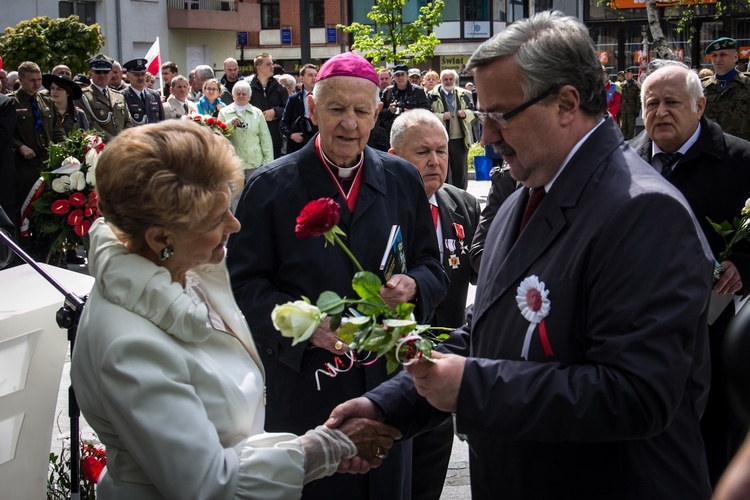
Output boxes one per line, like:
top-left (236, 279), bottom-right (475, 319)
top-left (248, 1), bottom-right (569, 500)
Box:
top-left (327, 11), bottom-right (713, 500)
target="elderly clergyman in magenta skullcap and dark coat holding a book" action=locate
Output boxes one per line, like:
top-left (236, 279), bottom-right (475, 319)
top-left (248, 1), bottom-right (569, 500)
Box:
top-left (227, 52), bottom-right (447, 500)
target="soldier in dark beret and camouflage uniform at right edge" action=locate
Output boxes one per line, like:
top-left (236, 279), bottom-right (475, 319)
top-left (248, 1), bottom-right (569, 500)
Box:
top-left (703, 37), bottom-right (750, 141)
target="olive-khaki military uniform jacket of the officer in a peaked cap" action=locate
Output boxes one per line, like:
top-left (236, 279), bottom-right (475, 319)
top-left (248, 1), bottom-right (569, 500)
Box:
top-left (75, 84), bottom-right (133, 142)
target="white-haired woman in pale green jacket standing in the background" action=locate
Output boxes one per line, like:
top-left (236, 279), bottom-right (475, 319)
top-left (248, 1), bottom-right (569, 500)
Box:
top-left (219, 80), bottom-right (273, 181)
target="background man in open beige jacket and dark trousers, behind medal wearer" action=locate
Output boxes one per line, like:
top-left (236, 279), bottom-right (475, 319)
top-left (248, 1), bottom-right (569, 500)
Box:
top-left (428, 69), bottom-right (474, 189)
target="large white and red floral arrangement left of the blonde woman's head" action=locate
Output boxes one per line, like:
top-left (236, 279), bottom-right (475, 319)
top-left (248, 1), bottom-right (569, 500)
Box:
top-left (21, 129), bottom-right (104, 262)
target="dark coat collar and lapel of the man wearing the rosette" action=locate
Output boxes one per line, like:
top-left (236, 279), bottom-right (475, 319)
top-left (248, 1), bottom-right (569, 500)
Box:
top-left (474, 118), bottom-right (623, 321)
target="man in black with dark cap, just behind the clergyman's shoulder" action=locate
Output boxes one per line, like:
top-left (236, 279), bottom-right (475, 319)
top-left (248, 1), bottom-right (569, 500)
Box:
top-left (369, 64), bottom-right (430, 151)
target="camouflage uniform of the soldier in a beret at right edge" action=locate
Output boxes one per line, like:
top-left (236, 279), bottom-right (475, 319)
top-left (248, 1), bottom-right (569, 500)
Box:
top-left (703, 73), bottom-right (750, 141)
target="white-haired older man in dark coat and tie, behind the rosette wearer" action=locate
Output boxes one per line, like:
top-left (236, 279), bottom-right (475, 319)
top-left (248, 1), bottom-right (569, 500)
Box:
top-left (630, 62), bottom-right (750, 485)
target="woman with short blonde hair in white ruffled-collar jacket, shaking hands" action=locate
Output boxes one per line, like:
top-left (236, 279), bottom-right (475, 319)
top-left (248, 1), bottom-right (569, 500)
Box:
top-left (71, 120), bottom-right (398, 500)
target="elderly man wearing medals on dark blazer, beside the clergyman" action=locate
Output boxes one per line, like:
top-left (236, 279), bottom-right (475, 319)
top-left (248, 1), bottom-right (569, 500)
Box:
top-left (388, 109), bottom-right (480, 500)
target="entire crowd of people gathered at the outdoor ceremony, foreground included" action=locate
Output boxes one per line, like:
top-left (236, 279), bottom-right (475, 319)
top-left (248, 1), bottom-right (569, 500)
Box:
top-left (0, 11), bottom-right (750, 500)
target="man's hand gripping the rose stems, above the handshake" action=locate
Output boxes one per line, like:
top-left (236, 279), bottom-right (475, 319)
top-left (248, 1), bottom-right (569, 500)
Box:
top-left (405, 351), bottom-right (466, 412)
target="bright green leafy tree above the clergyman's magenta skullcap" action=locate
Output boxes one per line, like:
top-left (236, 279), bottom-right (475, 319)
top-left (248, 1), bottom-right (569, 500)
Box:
top-left (338, 0), bottom-right (445, 64)
